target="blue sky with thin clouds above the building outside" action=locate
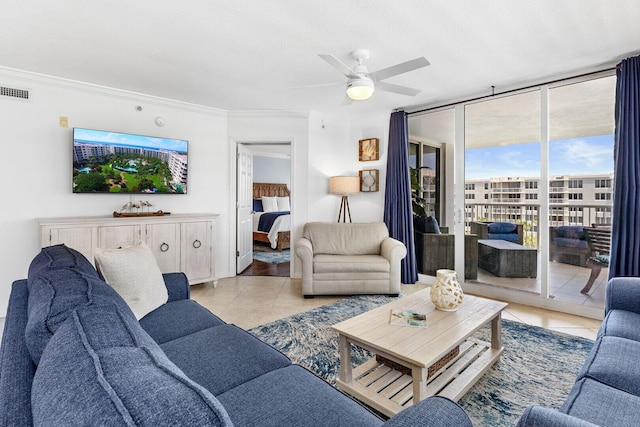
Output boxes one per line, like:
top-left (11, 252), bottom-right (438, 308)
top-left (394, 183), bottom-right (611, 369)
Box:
top-left (465, 135), bottom-right (613, 179)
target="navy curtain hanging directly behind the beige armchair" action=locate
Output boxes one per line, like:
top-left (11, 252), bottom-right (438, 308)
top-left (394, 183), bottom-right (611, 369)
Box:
top-left (384, 111), bottom-right (418, 283)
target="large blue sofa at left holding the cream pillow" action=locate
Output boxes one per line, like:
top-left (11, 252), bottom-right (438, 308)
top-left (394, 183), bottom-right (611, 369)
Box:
top-left (0, 245), bottom-right (471, 427)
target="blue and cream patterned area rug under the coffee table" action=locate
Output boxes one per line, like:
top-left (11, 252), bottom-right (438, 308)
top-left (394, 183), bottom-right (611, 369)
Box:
top-left (249, 296), bottom-right (593, 427)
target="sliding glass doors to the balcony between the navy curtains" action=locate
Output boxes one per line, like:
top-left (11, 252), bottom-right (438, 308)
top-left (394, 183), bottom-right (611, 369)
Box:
top-left (409, 75), bottom-right (615, 317)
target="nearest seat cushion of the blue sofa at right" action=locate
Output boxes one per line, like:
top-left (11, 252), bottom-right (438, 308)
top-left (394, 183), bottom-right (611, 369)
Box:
top-left (560, 378), bottom-right (640, 426)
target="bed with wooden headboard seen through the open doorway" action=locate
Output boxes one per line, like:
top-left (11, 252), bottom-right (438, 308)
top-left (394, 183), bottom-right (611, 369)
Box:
top-left (253, 182), bottom-right (291, 251)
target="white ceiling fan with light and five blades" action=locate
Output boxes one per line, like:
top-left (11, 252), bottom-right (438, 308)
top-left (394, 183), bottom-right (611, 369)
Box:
top-left (320, 49), bottom-right (430, 101)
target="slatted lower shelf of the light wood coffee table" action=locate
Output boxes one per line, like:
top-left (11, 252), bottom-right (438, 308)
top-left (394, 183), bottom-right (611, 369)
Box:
top-left (336, 338), bottom-right (503, 417)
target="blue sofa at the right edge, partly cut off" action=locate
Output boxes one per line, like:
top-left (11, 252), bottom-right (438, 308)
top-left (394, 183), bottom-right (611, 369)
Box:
top-left (518, 277), bottom-right (640, 427)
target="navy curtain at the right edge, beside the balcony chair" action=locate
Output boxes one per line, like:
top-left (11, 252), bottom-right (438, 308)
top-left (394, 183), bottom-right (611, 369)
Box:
top-left (609, 56), bottom-right (640, 278)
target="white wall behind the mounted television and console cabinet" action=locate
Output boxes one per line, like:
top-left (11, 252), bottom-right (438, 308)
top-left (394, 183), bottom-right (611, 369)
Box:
top-left (0, 69), bottom-right (230, 317)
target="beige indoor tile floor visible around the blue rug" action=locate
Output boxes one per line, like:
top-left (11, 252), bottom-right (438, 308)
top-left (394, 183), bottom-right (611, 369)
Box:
top-left (191, 276), bottom-right (601, 339)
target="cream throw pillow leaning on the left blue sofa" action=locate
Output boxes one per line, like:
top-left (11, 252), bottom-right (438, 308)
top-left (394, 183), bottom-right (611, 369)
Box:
top-left (95, 242), bottom-right (169, 320)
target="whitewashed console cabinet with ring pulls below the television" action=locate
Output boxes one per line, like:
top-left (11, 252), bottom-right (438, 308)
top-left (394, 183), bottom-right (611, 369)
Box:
top-left (38, 214), bottom-right (218, 285)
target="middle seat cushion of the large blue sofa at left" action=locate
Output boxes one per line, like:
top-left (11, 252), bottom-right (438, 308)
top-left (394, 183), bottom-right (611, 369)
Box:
top-left (160, 325), bottom-right (291, 395)
